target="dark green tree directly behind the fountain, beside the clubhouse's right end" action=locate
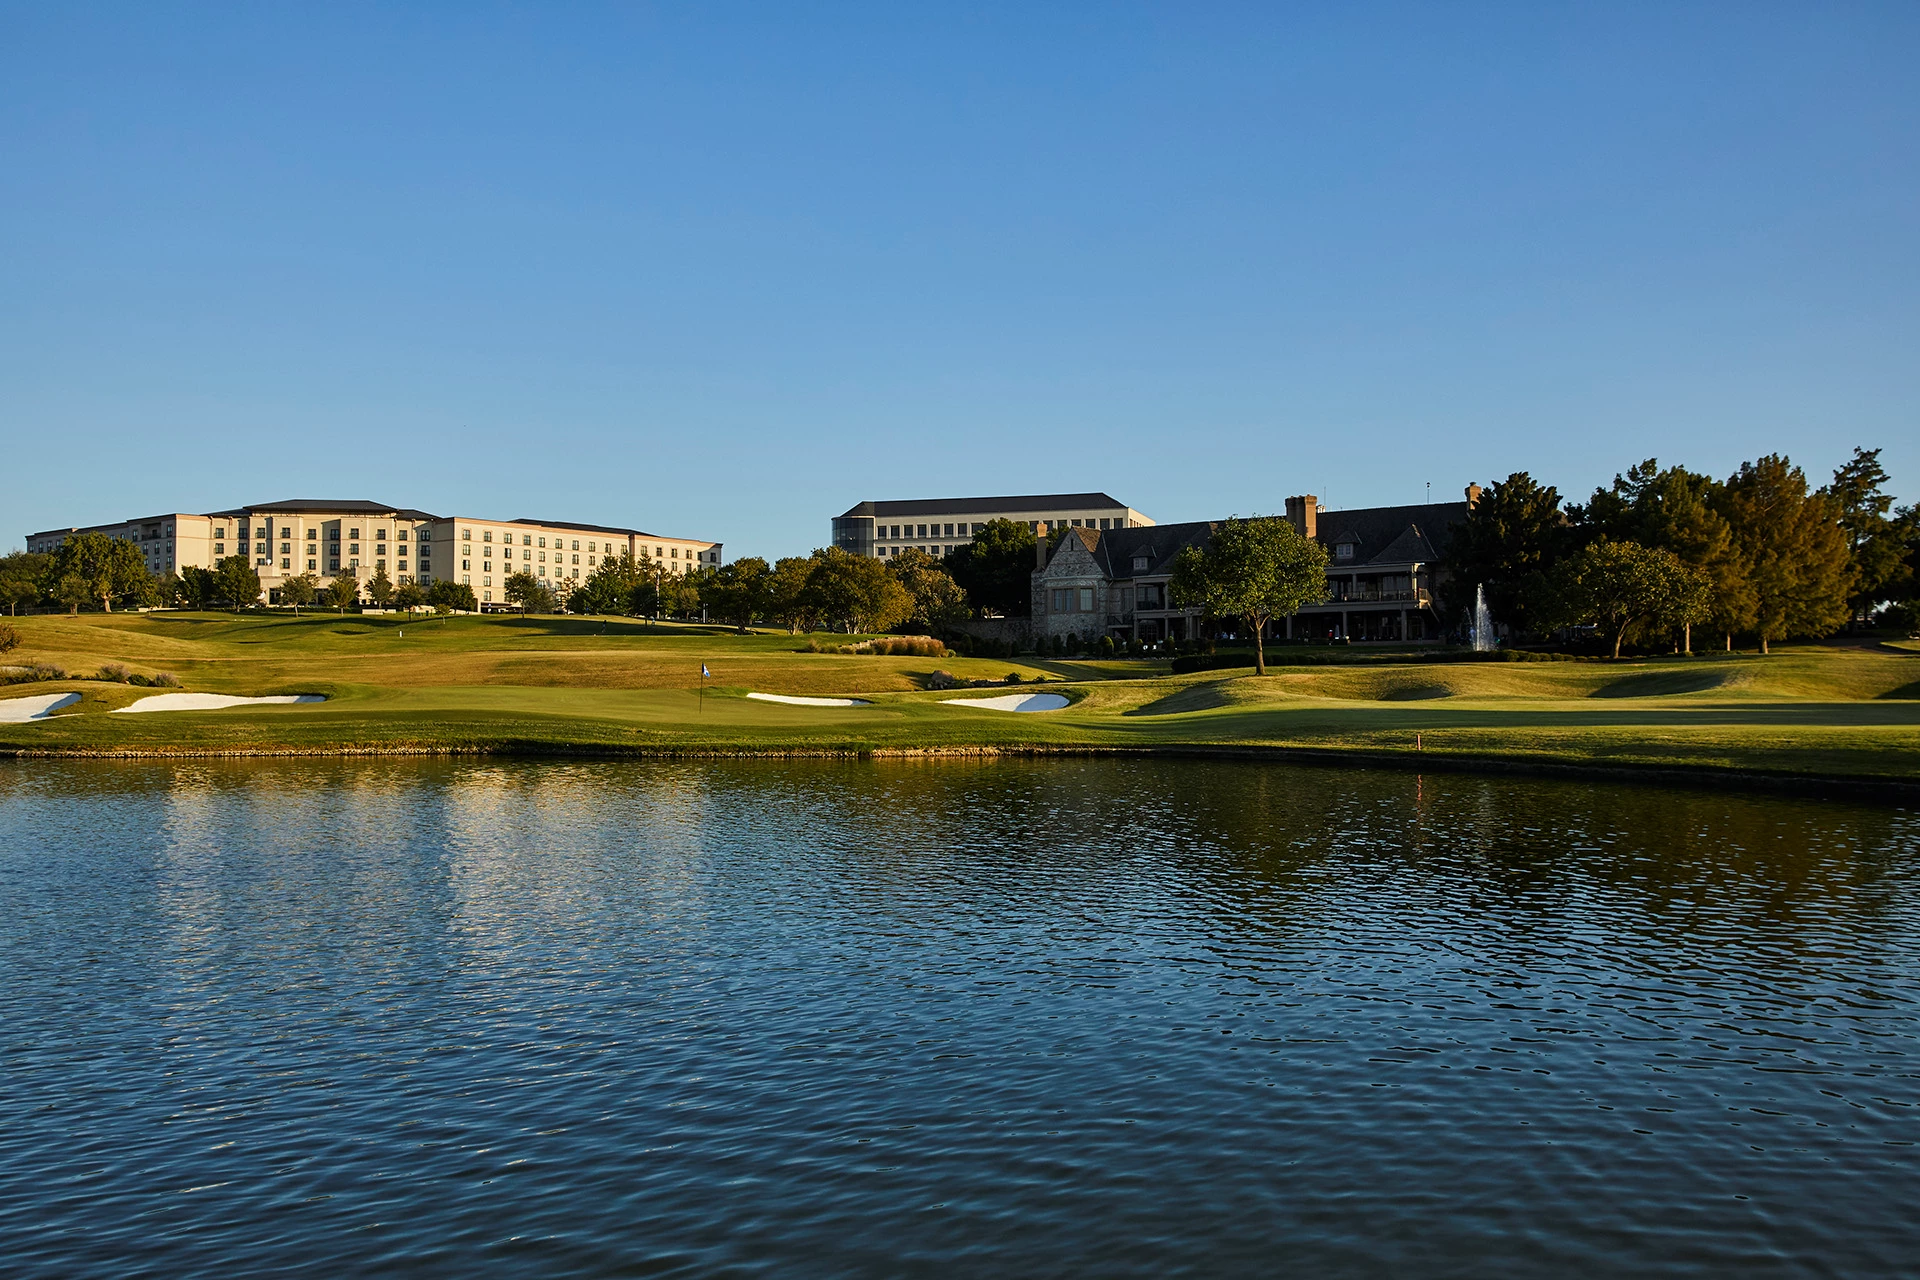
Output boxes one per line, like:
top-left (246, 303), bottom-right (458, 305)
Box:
top-left (1448, 472), bottom-right (1572, 631)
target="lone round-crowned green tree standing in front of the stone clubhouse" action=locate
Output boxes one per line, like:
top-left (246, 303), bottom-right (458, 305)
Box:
top-left (1167, 516), bottom-right (1327, 676)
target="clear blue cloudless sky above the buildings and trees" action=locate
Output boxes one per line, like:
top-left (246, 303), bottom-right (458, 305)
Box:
top-left (0, 2), bottom-right (1920, 557)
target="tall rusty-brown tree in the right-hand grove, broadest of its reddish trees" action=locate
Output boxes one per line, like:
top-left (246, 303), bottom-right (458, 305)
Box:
top-left (1720, 453), bottom-right (1851, 652)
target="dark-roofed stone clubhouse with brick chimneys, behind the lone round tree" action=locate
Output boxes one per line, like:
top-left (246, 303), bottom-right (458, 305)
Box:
top-left (1033, 489), bottom-right (1476, 641)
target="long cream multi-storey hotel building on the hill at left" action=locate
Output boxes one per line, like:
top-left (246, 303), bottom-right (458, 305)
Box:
top-left (27, 497), bottom-right (724, 606)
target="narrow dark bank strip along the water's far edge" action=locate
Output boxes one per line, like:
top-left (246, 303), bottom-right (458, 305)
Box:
top-left (0, 743), bottom-right (1920, 802)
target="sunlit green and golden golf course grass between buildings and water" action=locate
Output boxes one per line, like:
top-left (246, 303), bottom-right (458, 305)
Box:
top-left (0, 610), bottom-right (1920, 789)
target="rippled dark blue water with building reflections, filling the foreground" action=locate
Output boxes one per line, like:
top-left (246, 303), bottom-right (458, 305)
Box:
top-left (0, 760), bottom-right (1920, 1276)
